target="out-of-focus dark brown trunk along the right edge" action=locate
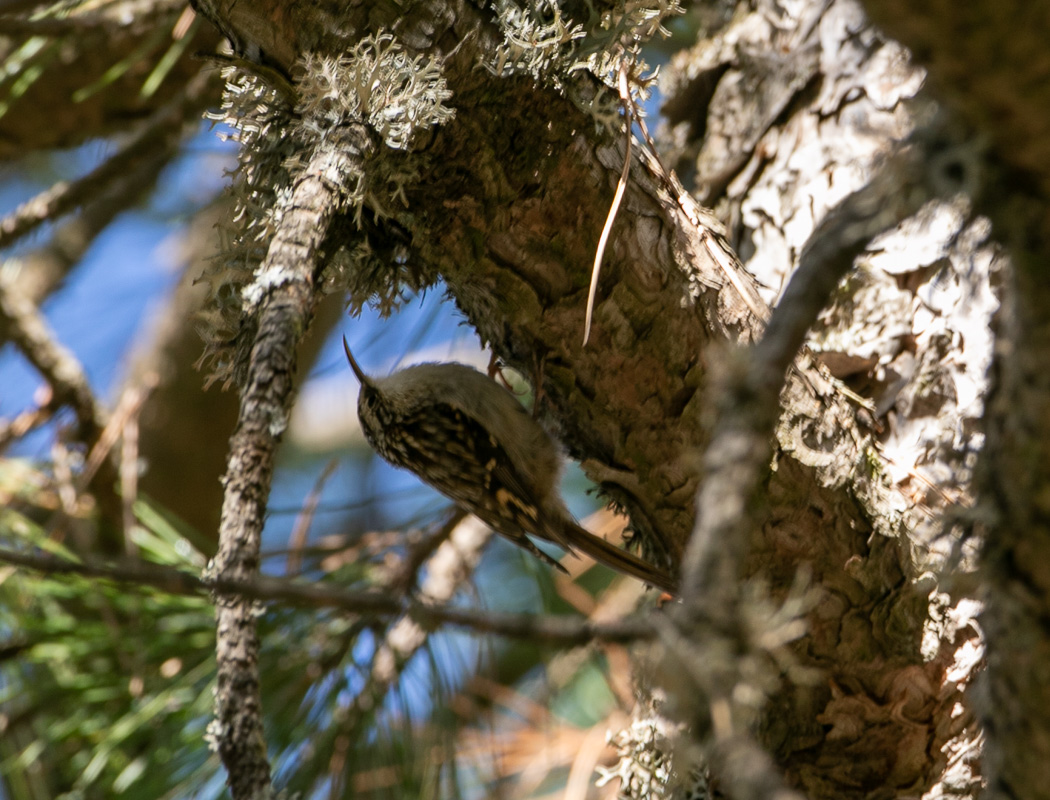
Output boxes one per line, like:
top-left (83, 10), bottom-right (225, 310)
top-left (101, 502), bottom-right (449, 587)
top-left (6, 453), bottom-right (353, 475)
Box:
top-left (856, 0), bottom-right (1050, 797)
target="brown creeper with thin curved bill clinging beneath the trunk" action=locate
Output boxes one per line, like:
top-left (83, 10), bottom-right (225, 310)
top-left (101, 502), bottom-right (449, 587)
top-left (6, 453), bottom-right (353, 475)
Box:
top-left (342, 337), bottom-right (678, 594)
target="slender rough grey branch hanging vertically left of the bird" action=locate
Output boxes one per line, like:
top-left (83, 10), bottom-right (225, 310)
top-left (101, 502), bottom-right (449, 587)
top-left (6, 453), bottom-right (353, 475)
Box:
top-left (209, 117), bottom-right (370, 800)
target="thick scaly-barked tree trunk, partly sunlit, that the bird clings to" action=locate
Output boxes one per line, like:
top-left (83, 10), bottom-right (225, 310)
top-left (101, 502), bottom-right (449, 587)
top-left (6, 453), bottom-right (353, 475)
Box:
top-left (186, 0), bottom-right (999, 798)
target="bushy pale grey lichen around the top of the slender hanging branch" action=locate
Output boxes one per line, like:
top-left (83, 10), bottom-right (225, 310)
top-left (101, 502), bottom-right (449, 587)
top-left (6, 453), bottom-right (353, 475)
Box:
top-left (202, 31), bottom-right (455, 381)
